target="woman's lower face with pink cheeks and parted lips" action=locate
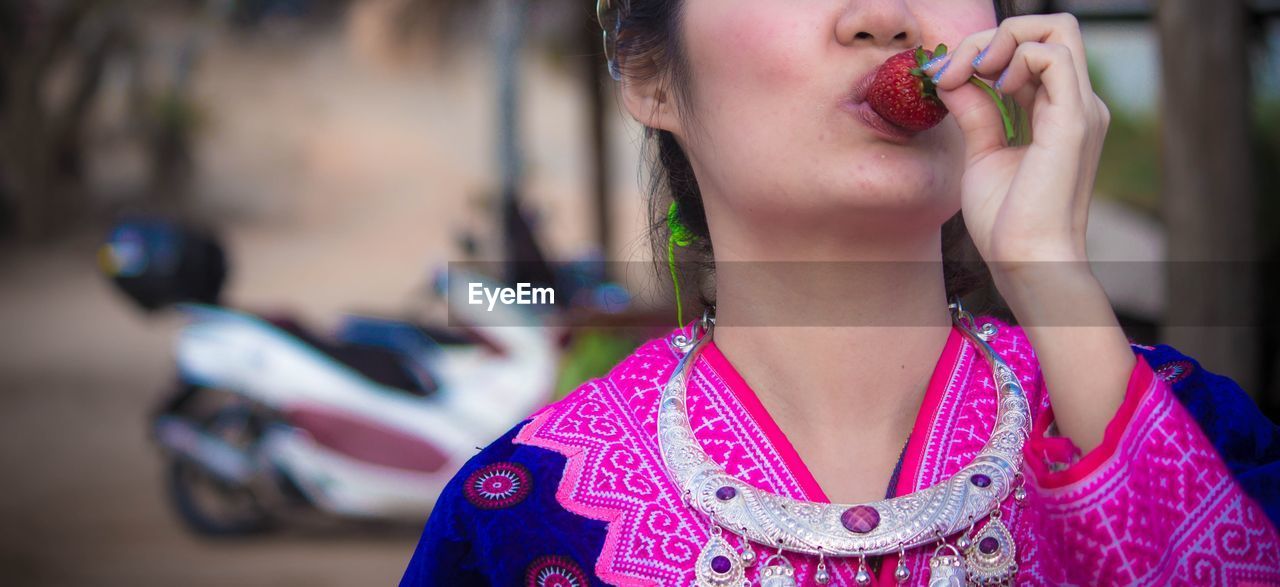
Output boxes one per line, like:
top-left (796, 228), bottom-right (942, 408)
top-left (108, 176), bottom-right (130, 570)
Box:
top-left (673, 0), bottom-right (996, 245)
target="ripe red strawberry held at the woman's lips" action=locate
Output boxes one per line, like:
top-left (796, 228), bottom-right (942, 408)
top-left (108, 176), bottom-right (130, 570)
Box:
top-left (867, 45), bottom-right (947, 132)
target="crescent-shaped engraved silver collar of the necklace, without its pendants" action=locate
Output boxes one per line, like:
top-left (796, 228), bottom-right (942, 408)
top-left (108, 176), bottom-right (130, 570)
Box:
top-left (658, 303), bottom-right (1030, 556)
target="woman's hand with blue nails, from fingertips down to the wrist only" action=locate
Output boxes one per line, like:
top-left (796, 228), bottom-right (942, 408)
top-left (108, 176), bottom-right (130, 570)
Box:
top-left (927, 13), bottom-right (1111, 272)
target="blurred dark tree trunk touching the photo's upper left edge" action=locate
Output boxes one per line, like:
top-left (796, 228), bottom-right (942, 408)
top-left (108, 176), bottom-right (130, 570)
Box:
top-left (0, 0), bottom-right (119, 239)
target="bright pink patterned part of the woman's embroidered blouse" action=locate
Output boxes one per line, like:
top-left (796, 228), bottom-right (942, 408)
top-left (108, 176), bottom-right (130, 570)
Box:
top-left (406, 317), bottom-right (1280, 586)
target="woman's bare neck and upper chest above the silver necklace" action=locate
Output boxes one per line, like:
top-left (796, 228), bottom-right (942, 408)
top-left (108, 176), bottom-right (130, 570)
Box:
top-left (714, 218), bottom-right (951, 442)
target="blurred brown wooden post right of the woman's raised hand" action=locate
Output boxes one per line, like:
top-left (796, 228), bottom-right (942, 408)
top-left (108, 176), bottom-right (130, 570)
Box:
top-left (1157, 0), bottom-right (1260, 395)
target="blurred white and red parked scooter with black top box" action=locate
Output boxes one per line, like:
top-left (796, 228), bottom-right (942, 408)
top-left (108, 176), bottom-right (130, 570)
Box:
top-left (100, 220), bottom-right (573, 535)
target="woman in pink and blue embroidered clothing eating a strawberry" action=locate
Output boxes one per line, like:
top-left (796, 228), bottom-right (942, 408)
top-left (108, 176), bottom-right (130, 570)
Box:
top-left (403, 0), bottom-right (1280, 586)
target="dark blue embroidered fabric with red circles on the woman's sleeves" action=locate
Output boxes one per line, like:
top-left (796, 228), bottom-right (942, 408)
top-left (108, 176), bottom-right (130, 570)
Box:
top-left (401, 344), bottom-right (1280, 587)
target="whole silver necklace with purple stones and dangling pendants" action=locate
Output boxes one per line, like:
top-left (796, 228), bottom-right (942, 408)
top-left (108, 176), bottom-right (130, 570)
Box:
top-left (658, 301), bottom-right (1030, 587)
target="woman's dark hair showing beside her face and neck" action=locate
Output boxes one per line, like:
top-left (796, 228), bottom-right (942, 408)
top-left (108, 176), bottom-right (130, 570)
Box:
top-left (617, 0), bottom-right (1024, 321)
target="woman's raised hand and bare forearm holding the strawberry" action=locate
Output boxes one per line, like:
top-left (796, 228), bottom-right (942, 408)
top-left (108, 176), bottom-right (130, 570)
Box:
top-left (929, 14), bottom-right (1135, 451)
